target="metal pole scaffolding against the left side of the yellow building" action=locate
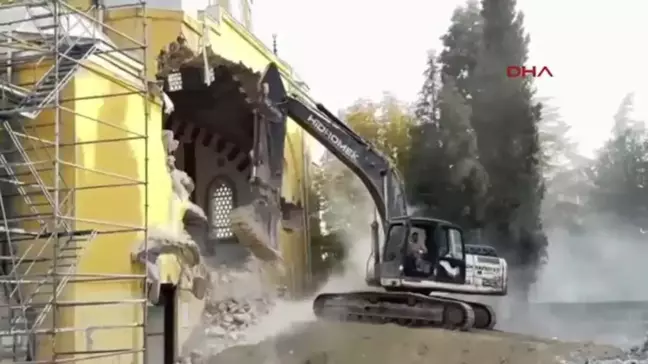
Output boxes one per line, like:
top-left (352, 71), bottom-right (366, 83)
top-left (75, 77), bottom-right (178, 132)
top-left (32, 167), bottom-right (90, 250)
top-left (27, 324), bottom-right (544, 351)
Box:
top-left (0, 0), bottom-right (150, 363)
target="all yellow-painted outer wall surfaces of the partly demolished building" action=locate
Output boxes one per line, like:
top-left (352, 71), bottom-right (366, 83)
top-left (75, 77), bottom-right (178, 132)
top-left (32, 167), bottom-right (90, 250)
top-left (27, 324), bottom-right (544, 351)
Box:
top-left (9, 2), bottom-right (314, 363)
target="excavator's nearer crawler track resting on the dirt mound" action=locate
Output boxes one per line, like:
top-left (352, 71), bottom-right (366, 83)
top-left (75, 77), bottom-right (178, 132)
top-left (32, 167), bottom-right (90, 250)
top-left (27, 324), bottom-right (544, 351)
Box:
top-left (313, 291), bottom-right (475, 331)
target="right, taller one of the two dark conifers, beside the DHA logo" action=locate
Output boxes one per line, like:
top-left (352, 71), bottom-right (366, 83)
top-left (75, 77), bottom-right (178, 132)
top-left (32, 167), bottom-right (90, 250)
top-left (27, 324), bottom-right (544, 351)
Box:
top-left (472, 0), bottom-right (547, 283)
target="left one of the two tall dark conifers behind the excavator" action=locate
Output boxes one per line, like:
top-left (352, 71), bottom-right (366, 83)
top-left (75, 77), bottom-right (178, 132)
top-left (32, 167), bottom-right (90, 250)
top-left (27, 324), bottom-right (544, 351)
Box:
top-left (408, 1), bottom-right (488, 239)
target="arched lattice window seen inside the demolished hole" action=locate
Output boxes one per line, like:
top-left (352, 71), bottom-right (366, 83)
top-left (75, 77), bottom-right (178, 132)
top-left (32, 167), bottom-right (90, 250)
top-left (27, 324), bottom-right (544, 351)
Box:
top-left (208, 178), bottom-right (234, 239)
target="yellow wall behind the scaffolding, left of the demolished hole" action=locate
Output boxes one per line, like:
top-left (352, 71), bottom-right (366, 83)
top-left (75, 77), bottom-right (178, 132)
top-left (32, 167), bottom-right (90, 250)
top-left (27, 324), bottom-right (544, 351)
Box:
top-left (11, 57), bottom-right (162, 363)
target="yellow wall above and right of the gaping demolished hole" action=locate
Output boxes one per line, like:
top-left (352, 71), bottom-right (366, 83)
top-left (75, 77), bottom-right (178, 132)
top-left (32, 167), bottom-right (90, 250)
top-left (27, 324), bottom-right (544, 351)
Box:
top-left (106, 9), bottom-right (310, 286)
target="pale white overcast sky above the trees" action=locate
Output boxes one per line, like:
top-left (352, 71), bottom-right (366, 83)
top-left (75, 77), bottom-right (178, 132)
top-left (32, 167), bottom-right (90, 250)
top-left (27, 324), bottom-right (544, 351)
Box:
top-left (253, 0), bottom-right (648, 158)
